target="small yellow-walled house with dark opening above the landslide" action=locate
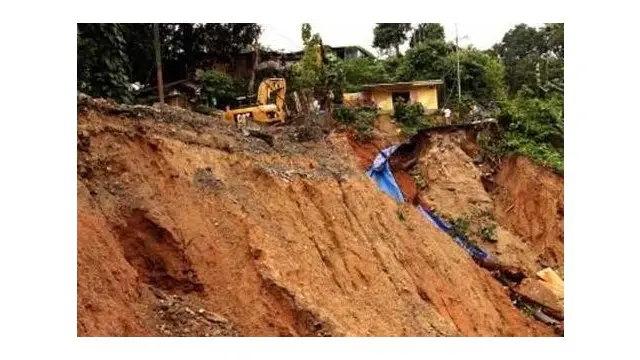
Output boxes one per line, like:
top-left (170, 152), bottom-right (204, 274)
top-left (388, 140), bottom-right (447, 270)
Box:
top-left (344, 80), bottom-right (443, 114)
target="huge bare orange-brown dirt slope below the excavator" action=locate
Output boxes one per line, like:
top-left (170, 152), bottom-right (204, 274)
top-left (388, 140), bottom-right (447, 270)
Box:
top-left (78, 97), bottom-right (552, 336)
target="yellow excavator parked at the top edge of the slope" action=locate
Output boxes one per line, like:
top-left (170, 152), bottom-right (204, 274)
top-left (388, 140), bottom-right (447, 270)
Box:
top-left (224, 78), bottom-right (287, 127)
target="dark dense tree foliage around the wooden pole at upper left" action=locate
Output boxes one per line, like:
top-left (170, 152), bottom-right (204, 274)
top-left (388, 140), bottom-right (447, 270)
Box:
top-left (77, 23), bottom-right (261, 101)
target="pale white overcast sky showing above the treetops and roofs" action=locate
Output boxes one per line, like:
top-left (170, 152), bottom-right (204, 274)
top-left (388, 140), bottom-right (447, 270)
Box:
top-left (260, 22), bottom-right (543, 55)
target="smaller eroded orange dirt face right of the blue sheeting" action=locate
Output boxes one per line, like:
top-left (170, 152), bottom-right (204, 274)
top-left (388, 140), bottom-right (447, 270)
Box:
top-left (384, 131), bottom-right (564, 277)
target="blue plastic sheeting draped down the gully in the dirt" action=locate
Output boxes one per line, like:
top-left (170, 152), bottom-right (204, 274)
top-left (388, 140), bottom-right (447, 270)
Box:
top-left (367, 145), bottom-right (489, 259)
